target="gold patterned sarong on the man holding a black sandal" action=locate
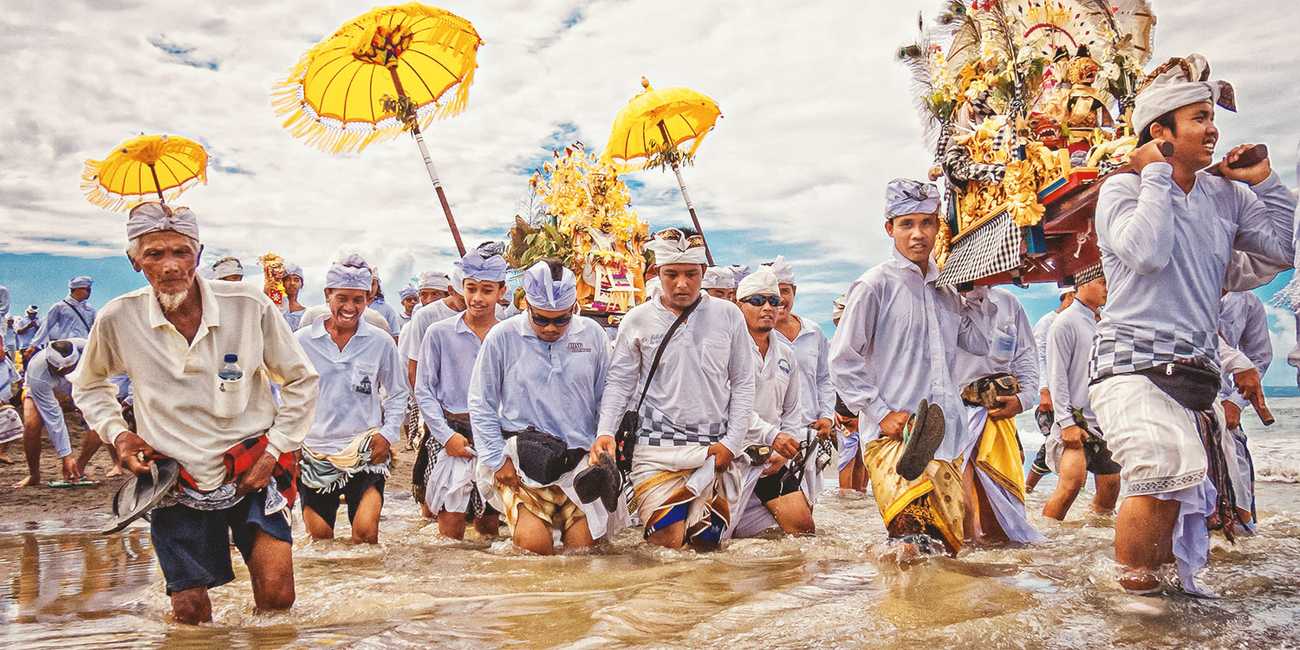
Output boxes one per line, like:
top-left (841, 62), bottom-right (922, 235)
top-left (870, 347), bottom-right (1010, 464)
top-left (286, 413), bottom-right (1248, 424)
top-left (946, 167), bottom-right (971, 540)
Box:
top-left (862, 437), bottom-right (966, 551)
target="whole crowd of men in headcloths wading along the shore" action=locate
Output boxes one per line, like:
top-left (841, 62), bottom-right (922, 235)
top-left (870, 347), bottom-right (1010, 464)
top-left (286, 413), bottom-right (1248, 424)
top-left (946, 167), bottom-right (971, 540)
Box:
top-left (4, 62), bottom-right (1296, 623)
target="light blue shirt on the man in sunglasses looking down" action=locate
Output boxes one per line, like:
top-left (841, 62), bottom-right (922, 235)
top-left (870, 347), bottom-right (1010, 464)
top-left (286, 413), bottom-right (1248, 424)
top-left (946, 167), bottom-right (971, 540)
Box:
top-left (469, 313), bottom-right (610, 471)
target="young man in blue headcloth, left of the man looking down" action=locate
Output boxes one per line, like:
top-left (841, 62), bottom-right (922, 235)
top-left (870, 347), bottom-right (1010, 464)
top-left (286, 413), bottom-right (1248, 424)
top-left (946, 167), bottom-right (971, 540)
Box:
top-left (411, 246), bottom-right (507, 540)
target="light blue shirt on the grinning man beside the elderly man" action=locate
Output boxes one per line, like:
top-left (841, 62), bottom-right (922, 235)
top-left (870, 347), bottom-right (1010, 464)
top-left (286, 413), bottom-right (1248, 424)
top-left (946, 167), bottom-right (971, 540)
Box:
top-left (294, 321), bottom-right (410, 454)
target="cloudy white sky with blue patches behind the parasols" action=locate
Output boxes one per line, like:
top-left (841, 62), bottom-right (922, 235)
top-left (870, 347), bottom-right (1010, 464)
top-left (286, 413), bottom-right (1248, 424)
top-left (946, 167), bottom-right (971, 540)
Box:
top-left (0, 0), bottom-right (1300, 384)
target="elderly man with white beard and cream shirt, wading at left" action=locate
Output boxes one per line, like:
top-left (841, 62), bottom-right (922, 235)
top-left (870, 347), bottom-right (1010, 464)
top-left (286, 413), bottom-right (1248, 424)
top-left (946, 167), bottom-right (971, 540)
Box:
top-left (73, 202), bottom-right (317, 624)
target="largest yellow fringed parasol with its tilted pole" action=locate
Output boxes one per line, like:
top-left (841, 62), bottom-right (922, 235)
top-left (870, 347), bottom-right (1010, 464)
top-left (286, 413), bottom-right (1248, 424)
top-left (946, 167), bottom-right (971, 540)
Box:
top-left (273, 3), bottom-right (482, 255)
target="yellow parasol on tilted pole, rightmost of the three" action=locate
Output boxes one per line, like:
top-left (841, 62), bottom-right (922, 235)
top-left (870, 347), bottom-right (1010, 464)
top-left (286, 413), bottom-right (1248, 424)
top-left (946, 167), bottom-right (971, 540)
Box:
top-left (602, 77), bottom-right (722, 265)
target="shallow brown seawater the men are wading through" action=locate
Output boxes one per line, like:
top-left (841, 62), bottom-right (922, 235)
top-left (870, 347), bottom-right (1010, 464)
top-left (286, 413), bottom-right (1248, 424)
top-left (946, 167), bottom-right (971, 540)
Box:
top-left (0, 399), bottom-right (1300, 649)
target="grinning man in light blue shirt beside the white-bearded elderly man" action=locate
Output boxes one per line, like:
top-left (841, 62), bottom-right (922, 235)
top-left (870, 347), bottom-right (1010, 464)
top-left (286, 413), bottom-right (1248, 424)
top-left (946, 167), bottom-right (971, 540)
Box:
top-left (295, 264), bottom-right (408, 543)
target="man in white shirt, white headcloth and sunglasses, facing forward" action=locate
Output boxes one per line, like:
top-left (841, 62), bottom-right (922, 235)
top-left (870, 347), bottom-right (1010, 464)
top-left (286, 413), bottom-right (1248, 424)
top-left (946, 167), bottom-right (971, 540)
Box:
top-left (729, 267), bottom-right (811, 537)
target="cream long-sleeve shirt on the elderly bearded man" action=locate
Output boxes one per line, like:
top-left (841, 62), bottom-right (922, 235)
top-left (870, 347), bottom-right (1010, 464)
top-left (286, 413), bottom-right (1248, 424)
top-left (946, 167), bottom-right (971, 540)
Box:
top-left (72, 278), bottom-right (319, 490)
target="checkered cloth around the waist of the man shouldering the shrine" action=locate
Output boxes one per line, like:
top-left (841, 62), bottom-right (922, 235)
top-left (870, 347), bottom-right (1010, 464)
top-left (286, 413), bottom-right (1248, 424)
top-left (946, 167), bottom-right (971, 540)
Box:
top-left (1088, 321), bottom-right (1218, 380)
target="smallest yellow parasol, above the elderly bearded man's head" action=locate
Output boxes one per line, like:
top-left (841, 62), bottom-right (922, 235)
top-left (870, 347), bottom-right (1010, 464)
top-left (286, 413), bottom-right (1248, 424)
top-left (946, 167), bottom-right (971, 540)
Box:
top-left (82, 135), bottom-right (208, 211)
